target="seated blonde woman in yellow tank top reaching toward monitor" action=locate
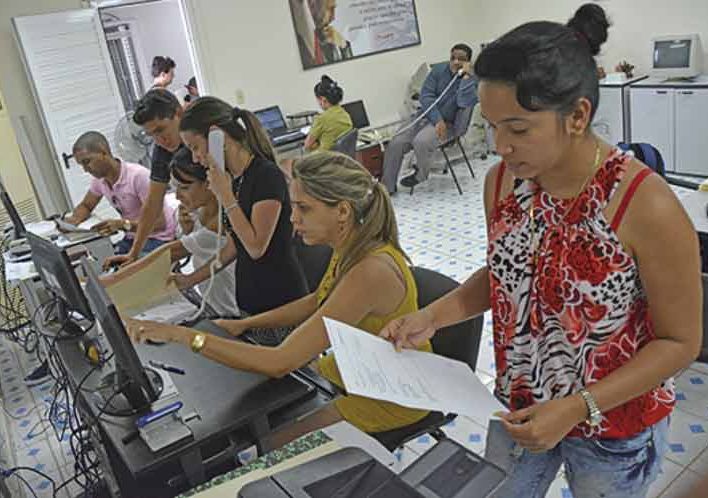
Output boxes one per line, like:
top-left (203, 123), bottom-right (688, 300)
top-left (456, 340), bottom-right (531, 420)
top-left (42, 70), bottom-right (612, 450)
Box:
top-left (129, 152), bottom-right (431, 443)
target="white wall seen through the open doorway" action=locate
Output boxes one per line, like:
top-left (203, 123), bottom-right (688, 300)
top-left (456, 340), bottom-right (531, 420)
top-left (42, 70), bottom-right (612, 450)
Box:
top-left (101, 0), bottom-right (195, 93)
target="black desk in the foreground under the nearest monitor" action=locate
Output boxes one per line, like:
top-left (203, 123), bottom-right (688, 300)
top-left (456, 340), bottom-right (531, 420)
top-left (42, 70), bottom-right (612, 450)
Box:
top-left (58, 322), bottom-right (331, 497)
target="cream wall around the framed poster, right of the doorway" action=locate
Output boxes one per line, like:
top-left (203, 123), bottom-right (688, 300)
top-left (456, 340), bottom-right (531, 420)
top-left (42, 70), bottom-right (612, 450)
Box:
top-left (187, 0), bottom-right (479, 124)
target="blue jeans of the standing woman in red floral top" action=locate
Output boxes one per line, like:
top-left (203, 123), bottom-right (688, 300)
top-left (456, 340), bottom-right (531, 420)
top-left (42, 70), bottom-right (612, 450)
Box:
top-left (485, 417), bottom-right (669, 498)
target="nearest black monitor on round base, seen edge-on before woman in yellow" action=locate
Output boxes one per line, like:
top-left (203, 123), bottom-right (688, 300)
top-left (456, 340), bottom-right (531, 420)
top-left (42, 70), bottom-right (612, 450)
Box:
top-left (81, 259), bottom-right (162, 414)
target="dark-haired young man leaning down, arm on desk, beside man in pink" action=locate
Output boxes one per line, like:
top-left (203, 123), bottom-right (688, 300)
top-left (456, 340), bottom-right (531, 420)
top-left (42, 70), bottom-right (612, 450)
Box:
top-left (104, 89), bottom-right (183, 268)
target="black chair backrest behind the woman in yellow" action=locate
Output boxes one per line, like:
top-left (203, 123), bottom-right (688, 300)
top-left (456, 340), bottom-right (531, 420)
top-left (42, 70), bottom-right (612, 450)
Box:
top-left (411, 266), bottom-right (484, 370)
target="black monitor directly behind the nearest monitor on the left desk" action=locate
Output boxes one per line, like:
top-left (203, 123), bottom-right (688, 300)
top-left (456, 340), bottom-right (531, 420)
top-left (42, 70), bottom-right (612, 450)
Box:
top-left (25, 232), bottom-right (93, 322)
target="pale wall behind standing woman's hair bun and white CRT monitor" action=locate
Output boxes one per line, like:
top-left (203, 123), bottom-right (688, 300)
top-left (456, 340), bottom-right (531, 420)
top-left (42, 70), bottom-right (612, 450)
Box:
top-left (475, 0), bottom-right (708, 78)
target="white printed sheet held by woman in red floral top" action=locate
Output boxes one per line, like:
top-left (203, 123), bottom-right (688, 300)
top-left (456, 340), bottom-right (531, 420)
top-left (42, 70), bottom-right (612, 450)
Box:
top-left (324, 318), bottom-right (507, 420)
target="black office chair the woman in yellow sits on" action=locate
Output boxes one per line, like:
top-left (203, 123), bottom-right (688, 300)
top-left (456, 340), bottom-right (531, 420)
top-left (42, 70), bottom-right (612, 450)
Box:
top-left (369, 267), bottom-right (484, 451)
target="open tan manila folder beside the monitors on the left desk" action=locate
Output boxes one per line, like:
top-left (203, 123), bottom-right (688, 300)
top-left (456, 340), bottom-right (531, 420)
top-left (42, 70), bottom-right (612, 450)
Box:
top-left (106, 251), bottom-right (196, 321)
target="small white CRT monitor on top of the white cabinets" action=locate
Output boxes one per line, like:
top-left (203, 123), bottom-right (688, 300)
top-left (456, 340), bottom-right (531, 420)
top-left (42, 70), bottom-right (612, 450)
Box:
top-left (651, 34), bottom-right (703, 79)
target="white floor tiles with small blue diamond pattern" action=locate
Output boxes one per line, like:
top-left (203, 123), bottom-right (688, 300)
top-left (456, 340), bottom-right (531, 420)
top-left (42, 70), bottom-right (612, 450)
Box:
top-left (0, 154), bottom-right (708, 498)
